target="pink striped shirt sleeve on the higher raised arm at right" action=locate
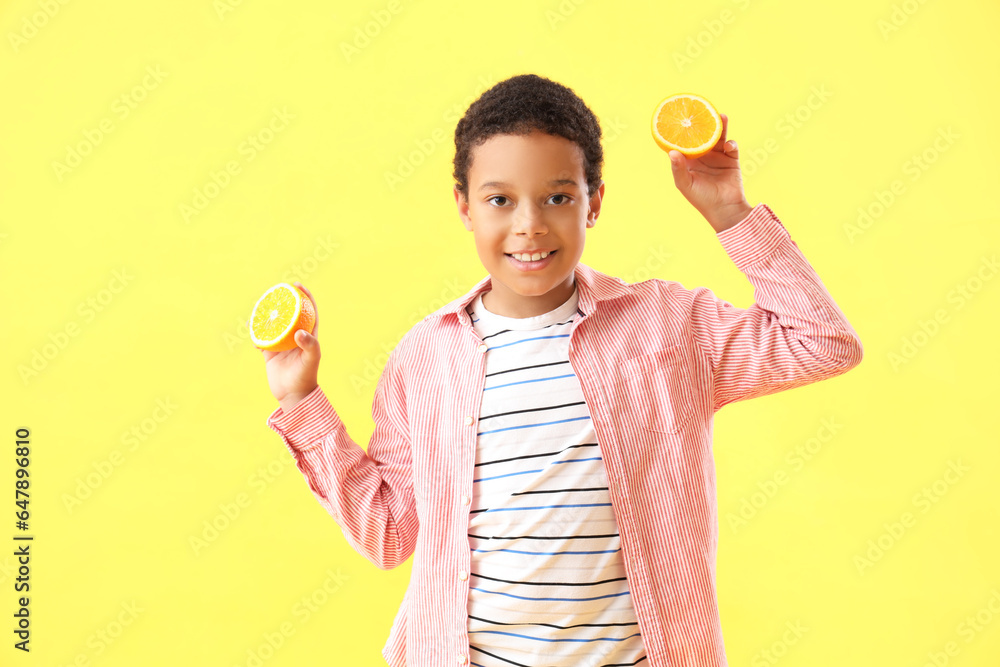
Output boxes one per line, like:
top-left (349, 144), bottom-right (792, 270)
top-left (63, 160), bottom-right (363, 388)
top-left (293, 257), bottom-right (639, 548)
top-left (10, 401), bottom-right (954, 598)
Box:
top-left (691, 203), bottom-right (863, 410)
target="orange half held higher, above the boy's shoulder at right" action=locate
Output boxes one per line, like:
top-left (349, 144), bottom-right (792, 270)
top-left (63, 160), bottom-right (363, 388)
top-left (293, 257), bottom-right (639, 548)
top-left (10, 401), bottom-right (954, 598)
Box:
top-left (653, 93), bottom-right (722, 157)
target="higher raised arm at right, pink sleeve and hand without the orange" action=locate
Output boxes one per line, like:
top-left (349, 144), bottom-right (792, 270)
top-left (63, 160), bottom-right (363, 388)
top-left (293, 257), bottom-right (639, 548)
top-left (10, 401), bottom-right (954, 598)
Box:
top-left (670, 114), bottom-right (863, 410)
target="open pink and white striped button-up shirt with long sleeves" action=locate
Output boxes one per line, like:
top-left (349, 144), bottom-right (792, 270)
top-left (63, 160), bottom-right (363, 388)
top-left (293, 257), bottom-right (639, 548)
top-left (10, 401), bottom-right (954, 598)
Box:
top-left (267, 204), bottom-right (862, 667)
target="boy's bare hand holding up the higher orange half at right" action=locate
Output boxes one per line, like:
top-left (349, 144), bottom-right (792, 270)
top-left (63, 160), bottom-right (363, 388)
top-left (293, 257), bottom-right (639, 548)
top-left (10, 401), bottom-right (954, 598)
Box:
top-left (669, 114), bottom-right (753, 233)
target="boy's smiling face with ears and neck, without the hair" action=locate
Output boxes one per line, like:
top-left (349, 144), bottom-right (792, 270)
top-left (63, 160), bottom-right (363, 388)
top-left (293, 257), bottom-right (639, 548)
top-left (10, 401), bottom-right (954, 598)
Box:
top-left (454, 130), bottom-right (604, 317)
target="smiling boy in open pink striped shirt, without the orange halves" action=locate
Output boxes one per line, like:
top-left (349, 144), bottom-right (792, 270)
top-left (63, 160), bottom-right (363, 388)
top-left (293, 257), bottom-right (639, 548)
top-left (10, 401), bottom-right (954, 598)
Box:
top-left (264, 75), bottom-right (862, 667)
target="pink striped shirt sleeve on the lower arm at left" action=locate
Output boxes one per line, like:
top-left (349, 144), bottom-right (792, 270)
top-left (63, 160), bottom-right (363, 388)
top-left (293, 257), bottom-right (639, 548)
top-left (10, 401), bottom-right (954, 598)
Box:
top-left (267, 351), bottom-right (418, 569)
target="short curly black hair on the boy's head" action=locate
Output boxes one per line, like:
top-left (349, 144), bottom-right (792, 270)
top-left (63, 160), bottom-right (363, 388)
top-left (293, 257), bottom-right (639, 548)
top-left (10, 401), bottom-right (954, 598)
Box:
top-left (452, 74), bottom-right (604, 200)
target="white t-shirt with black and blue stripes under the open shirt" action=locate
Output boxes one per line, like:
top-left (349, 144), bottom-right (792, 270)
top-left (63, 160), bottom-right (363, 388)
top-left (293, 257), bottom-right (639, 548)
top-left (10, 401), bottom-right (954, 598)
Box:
top-left (468, 289), bottom-right (646, 667)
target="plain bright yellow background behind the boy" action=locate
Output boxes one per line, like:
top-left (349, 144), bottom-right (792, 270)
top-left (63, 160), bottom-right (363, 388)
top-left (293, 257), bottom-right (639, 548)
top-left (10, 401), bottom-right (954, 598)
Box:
top-left (0, 0), bottom-right (1000, 667)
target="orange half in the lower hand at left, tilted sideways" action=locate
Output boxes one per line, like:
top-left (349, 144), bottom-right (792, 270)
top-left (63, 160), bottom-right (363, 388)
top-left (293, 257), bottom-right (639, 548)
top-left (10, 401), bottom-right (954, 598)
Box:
top-left (247, 283), bottom-right (316, 351)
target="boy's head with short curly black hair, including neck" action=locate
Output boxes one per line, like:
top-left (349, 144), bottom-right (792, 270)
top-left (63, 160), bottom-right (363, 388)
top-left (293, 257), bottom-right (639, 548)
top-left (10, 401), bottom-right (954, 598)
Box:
top-left (454, 74), bottom-right (604, 317)
